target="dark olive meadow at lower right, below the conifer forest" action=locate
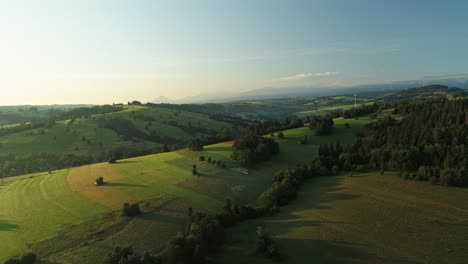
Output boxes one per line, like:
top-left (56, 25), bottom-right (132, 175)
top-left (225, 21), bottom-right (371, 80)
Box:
top-left (217, 174), bottom-right (468, 263)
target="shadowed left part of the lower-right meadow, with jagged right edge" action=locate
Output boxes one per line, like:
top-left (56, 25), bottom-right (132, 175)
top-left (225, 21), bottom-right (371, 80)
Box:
top-left (222, 176), bottom-right (405, 264)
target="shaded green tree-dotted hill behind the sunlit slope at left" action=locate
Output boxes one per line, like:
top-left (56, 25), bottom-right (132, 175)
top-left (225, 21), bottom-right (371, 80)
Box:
top-left (0, 106), bottom-right (241, 177)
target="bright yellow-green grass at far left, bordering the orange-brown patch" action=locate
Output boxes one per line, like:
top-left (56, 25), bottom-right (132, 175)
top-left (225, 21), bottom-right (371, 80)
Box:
top-left (0, 170), bottom-right (107, 261)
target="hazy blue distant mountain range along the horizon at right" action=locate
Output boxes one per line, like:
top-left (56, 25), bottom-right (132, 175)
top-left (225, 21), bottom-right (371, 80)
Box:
top-left (152, 75), bottom-right (468, 104)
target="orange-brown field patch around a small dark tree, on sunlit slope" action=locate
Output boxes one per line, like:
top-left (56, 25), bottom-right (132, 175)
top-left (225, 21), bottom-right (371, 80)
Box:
top-left (67, 163), bottom-right (135, 209)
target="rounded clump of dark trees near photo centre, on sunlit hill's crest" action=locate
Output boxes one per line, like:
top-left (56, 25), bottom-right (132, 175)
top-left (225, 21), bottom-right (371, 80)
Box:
top-left (232, 135), bottom-right (279, 166)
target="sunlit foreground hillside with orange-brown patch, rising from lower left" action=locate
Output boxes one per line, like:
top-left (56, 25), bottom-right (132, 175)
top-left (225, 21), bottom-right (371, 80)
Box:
top-left (0, 115), bottom-right (367, 263)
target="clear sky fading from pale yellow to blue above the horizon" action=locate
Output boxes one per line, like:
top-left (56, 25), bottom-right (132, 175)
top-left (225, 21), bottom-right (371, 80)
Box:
top-left (0, 0), bottom-right (468, 104)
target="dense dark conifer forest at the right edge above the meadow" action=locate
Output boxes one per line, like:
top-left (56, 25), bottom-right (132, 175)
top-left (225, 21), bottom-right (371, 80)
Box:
top-left (341, 99), bottom-right (468, 186)
